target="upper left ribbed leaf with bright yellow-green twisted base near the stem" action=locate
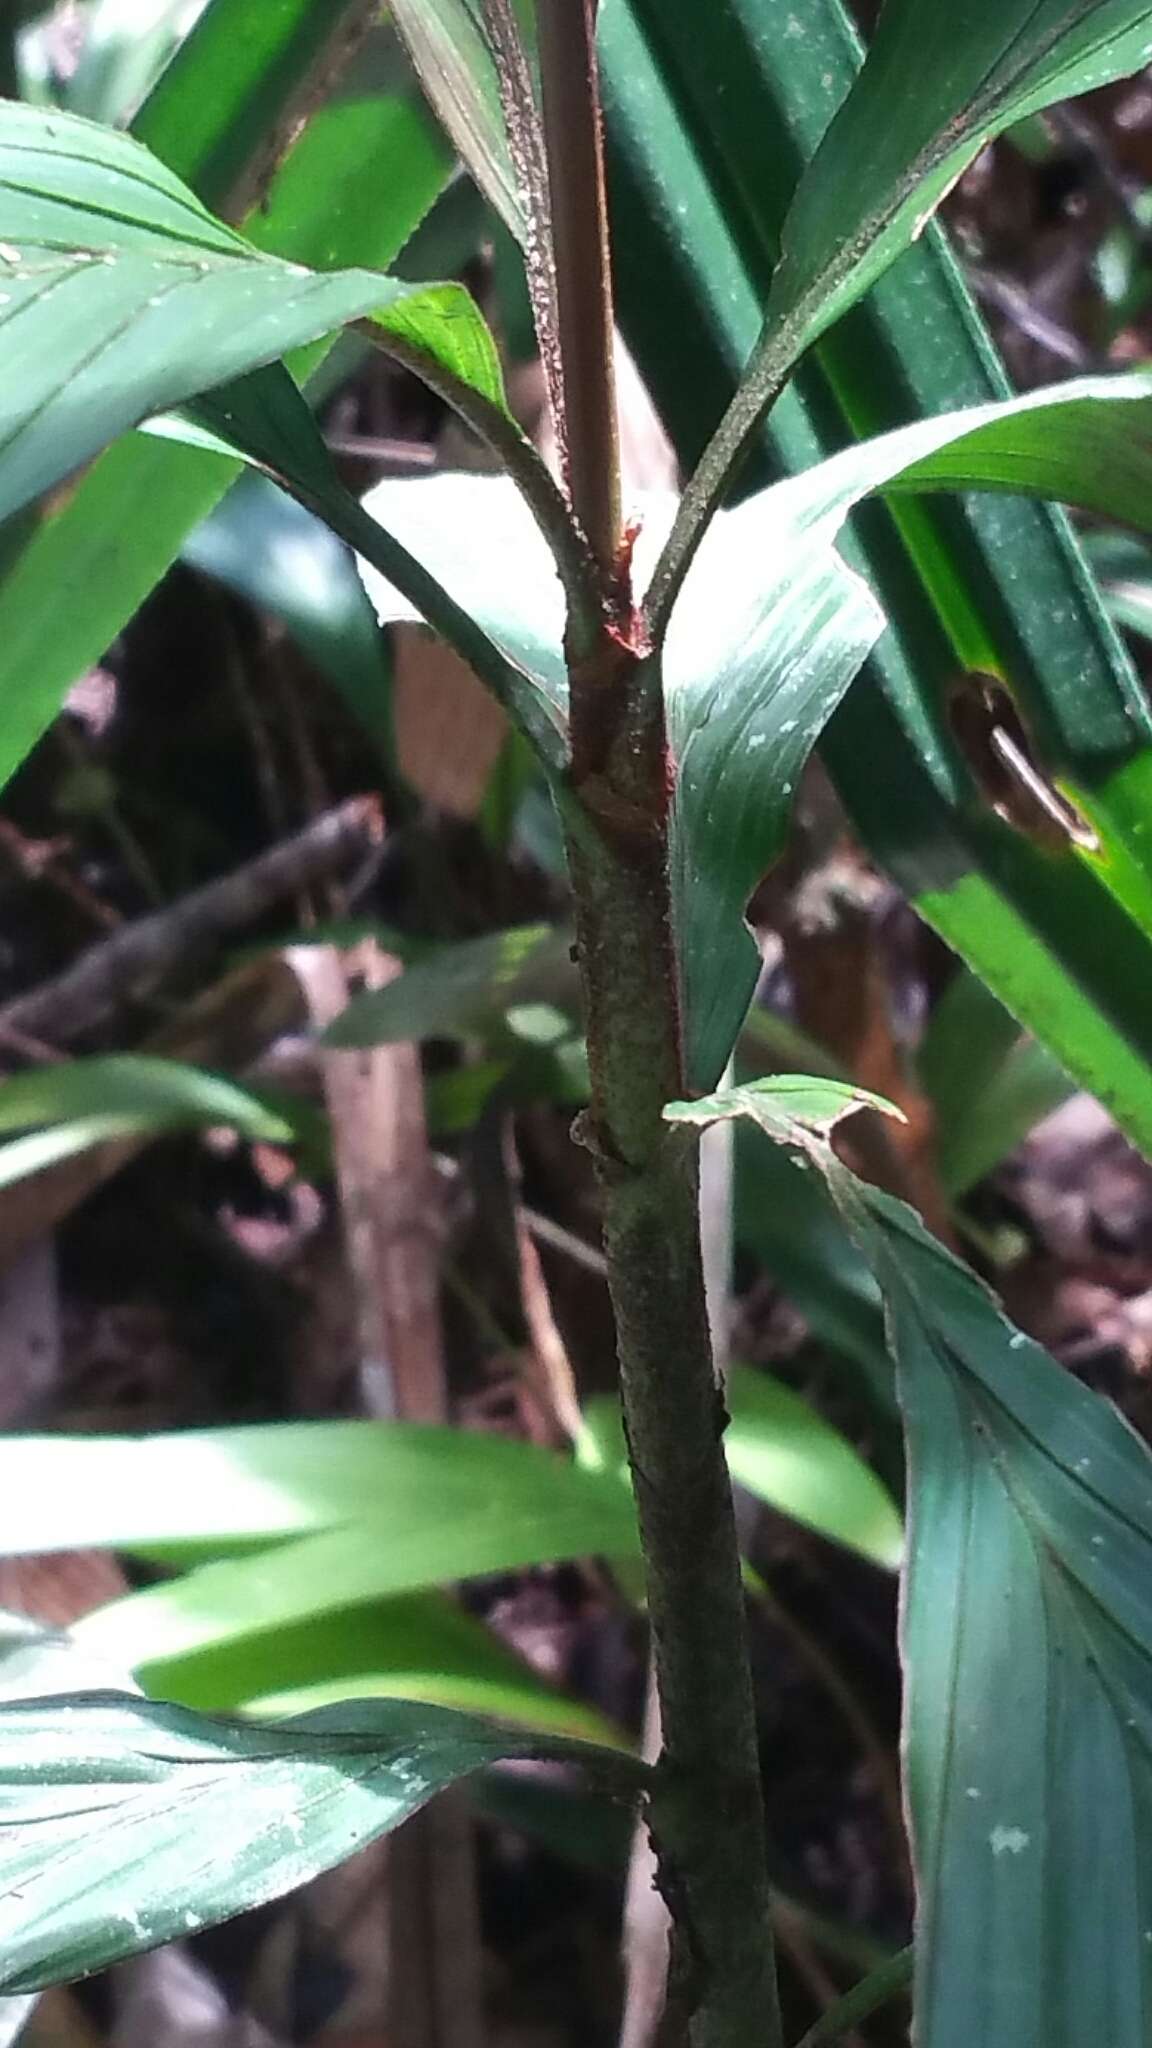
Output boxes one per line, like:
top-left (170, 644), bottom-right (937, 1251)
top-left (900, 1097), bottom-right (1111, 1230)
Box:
top-left (0, 104), bottom-right (492, 532)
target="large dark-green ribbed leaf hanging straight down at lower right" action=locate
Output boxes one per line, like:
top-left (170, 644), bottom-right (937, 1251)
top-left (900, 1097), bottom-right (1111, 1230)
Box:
top-left (660, 1090), bottom-right (1152, 2048)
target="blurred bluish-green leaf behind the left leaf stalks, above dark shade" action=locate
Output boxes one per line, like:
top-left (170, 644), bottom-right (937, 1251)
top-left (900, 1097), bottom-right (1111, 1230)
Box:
top-left (182, 475), bottom-right (396, 762)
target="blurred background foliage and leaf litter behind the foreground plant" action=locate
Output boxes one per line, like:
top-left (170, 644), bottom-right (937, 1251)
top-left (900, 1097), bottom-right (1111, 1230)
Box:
top-left (0, 0), bottom-right (1152, 2048)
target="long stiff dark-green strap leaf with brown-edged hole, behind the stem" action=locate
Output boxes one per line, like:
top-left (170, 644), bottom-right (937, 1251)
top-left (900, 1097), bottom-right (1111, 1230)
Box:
top-left (601, 0), bottom-right (1152, 1179)
